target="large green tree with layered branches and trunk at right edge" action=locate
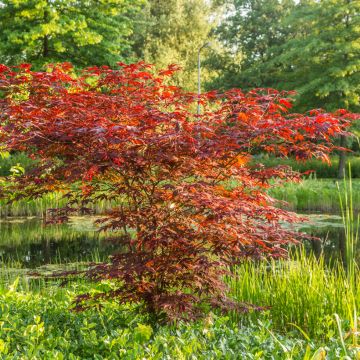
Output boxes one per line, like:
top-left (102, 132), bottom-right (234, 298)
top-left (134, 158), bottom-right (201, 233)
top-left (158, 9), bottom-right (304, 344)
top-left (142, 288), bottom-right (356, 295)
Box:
top-left (262, 0), bottom-right (360, 177)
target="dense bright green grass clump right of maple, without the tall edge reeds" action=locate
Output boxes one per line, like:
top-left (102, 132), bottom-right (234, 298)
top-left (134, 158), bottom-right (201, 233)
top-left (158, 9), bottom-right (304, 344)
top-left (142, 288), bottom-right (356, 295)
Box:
top-left (227, 250), bottom-right (360, 337)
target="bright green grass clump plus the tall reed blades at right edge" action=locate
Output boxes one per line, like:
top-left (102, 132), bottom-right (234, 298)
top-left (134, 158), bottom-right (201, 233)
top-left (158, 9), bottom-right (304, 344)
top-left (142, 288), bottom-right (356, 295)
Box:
top-left (227, 166), bottom-right (360, 338)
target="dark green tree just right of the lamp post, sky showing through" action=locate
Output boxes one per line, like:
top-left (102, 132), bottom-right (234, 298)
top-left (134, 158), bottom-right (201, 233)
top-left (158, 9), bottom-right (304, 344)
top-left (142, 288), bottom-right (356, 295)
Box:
top-left (212, 0), bottom-right (295, 88)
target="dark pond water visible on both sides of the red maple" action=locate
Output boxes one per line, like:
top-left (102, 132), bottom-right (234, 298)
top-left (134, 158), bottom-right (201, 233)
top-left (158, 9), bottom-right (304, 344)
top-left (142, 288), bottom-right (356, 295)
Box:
top-left (0, 214), bottom-right (345, 268)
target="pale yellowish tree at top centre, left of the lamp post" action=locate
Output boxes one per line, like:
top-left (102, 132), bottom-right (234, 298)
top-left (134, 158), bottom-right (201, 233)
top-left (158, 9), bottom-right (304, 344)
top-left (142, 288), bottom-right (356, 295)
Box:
top-left (135, 0), bottom-right (221, 90)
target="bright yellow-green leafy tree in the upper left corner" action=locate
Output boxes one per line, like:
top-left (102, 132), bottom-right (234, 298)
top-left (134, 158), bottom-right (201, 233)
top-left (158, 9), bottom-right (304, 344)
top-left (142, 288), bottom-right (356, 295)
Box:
top-left (0, 0), bottom-right (143, 66)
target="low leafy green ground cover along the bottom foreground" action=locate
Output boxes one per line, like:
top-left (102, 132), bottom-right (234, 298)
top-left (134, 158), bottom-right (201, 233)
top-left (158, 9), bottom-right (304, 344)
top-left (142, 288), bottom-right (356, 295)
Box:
top-left (0, 278), bottom-right (357, 360)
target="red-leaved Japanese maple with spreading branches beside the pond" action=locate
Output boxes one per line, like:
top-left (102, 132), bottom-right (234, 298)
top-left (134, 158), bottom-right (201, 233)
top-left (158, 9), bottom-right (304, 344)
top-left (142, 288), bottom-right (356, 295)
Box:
top-left (0, 63), bottom-right (352, 317)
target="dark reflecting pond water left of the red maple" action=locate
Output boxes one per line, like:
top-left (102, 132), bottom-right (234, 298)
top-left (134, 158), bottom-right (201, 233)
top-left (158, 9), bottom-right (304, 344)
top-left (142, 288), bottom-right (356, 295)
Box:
top-left (0, 217), bottom-right (118, 268)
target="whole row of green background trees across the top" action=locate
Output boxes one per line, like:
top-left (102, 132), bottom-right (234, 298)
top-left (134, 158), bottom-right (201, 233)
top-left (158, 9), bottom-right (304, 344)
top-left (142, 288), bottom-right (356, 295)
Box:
top-left (0, 0), bottom-right (360, 111)
